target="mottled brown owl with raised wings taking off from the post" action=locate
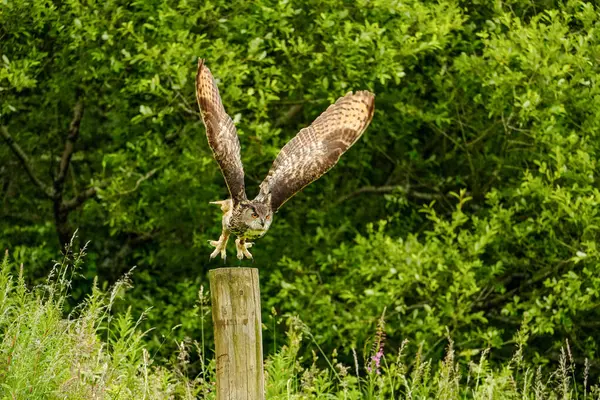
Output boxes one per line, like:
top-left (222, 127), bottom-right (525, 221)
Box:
top-left (196, 59), bottom-right (375, 260)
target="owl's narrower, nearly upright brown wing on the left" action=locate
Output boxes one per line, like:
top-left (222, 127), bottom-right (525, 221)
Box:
top-left (196, 59), bottom-right (246, 204)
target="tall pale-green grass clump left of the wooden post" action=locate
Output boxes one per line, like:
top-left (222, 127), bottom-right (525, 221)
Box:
top-left (0, 249), bottom-right (209, 399)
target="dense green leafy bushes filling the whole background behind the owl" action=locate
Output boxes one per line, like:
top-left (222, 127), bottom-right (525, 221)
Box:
top-left (0, 0), bottom-right (600, 373)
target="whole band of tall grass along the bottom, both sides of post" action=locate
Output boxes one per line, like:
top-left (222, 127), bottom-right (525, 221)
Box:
top-left (0, 245), bottom-right (600, 399)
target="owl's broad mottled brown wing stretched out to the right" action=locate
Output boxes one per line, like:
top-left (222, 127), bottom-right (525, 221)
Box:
top-left (259, 91), bottom-right (375, 212)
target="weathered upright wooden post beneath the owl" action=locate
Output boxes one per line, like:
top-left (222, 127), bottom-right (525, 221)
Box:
top-left (208, 268), bottom-right (264, 400)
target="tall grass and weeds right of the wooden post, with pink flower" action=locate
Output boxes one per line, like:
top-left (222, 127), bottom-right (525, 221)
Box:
top-left (266, 319), bottom-right (600, 400)
